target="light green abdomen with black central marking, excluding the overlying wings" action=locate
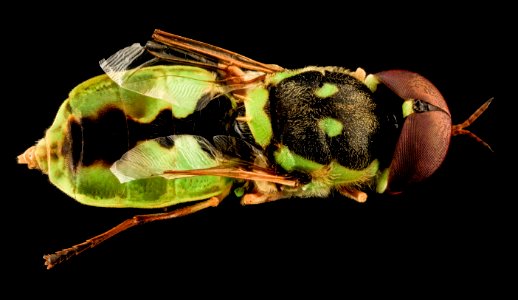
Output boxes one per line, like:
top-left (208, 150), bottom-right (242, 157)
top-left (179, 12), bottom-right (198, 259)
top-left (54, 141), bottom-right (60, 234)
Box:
top-left (35, 66), bottom-right (237, 208)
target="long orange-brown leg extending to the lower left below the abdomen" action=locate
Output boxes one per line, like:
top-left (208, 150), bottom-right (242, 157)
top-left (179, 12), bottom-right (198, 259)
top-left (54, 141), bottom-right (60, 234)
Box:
top-left (43, 193), bottom-right (226, 269)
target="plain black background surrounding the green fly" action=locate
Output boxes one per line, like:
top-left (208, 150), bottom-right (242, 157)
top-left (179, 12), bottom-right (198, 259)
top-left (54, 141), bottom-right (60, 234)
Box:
top-left (2, 1), bottom-right (512, 296)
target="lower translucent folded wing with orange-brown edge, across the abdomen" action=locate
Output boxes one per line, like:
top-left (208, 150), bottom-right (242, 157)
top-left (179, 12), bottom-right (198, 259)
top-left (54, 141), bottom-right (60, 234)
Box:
top-left (110, 135), bottom-right (298, 186)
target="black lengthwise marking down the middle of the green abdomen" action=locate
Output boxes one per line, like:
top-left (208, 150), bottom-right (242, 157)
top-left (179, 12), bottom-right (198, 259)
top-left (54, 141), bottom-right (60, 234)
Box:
top-left (67, 97), bottom-right (232, 170)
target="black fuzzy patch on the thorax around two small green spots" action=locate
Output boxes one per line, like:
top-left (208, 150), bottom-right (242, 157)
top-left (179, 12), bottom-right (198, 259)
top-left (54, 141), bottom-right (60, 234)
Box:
top-left (270, 71), bottom-right (379, 169)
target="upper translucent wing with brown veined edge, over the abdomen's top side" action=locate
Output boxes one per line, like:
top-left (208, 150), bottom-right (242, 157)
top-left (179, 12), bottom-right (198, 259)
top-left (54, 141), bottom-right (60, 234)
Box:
top-left (100, 30), bottom-right (283, 110)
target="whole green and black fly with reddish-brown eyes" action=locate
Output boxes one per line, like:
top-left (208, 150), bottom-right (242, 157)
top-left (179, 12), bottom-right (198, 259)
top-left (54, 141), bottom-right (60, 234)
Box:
top-left (18, 30), bottom-right (491, 269)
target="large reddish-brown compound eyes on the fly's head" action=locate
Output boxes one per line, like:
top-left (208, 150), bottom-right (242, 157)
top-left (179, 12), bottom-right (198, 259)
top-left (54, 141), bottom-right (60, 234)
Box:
top-left (376, 70), bottom-right (452, 192)
